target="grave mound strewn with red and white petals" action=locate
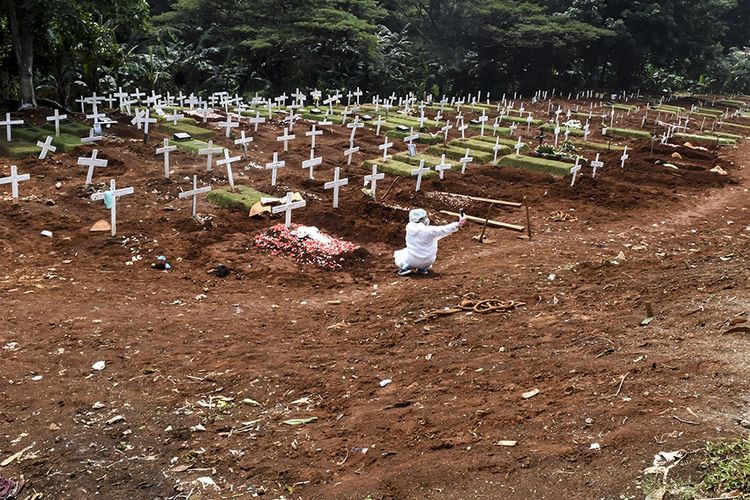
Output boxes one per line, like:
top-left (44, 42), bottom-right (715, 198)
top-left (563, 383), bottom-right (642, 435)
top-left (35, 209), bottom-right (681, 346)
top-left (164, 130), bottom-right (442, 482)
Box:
top-left (253, 224), bottom-right (364, 270)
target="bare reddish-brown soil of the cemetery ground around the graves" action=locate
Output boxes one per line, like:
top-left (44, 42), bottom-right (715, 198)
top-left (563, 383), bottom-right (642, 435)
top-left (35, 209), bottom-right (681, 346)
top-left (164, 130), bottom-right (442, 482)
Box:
top-left (0, 98), bottom-right (750, 499)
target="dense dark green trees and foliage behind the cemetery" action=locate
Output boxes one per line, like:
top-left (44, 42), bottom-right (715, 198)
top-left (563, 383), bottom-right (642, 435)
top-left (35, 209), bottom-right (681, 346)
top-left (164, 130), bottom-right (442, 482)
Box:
top-left (0, 0), bottom-right (750, 104)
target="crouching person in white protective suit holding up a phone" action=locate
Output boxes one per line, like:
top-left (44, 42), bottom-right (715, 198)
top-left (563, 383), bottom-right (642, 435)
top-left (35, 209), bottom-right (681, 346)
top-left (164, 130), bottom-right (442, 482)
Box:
top-left (393, 208), bottom-right (466, 276)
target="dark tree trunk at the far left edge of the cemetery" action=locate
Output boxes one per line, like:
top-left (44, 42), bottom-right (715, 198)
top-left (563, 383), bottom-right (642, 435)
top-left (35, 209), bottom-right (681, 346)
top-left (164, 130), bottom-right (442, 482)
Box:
top-left (5, 0), bottom-right (36, 108)
